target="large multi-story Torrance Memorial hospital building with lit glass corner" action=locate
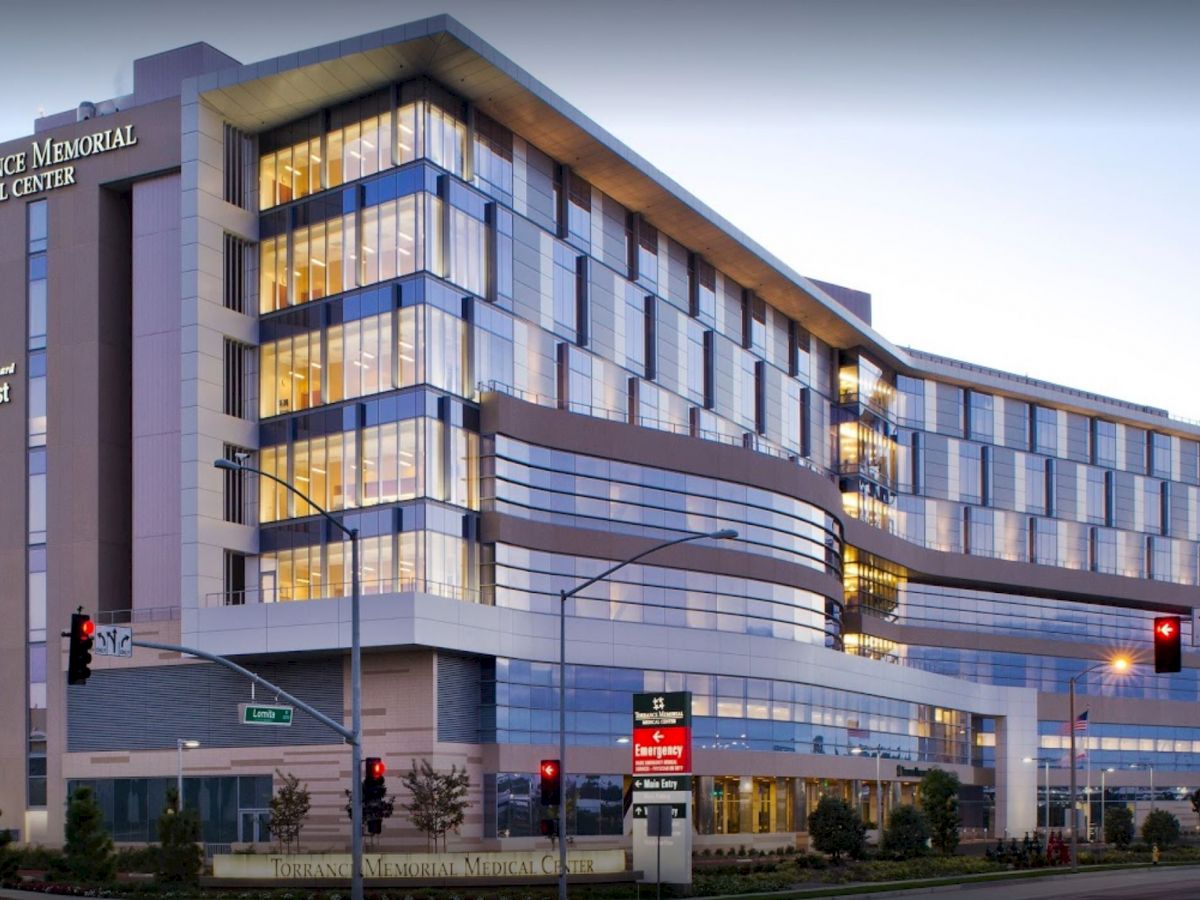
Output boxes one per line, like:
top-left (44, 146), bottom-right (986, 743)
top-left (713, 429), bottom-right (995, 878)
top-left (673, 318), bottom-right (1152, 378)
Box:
top-left (0, 18), bottom-right (1200, 847)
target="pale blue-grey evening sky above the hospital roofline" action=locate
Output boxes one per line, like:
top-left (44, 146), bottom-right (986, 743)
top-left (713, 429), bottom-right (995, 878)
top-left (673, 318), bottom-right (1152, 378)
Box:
top-left (0, 0), bottom-right (1200, 421)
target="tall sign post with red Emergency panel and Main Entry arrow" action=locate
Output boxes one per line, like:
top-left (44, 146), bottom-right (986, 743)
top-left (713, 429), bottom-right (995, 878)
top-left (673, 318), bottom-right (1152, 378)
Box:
top-left (632, 691), bottom-right (692, 884)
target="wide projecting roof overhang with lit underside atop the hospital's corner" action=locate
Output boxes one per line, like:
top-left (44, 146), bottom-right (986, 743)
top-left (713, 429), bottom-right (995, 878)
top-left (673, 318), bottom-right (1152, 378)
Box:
top-left (196, 16), bottom-right (908, 367)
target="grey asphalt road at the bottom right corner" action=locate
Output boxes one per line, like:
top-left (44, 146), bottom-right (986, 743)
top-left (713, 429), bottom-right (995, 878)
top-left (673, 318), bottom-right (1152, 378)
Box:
top-left (842, 865), bottom-right (1200, 900)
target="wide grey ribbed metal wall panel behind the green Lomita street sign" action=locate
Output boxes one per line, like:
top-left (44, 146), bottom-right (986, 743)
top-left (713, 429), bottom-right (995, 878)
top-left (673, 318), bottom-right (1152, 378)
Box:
top-left (67, 656), bottom-right (344, 752)
